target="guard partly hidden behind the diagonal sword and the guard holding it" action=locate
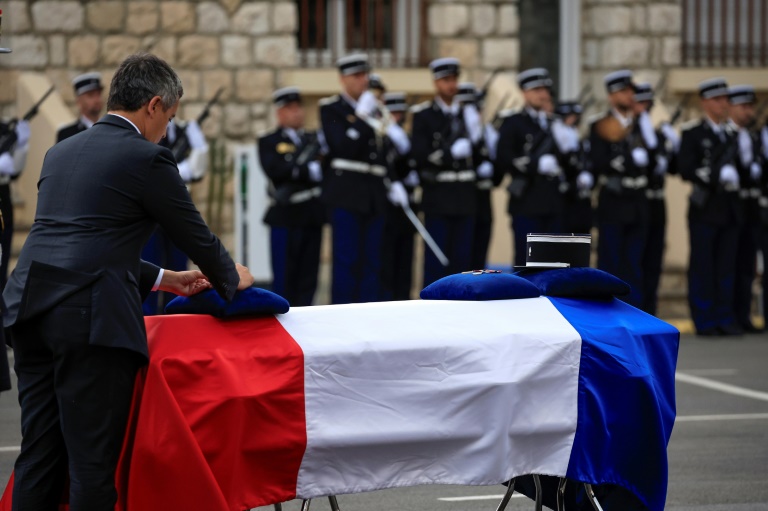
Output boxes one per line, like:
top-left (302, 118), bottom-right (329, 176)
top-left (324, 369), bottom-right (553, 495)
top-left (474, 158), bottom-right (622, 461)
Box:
top-left (381, 92), bottom-right (419, 300)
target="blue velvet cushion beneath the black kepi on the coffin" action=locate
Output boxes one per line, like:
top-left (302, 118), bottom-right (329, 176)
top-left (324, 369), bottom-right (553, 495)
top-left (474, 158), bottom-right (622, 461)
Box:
top-left (520, 268), bottom-right (630, 298)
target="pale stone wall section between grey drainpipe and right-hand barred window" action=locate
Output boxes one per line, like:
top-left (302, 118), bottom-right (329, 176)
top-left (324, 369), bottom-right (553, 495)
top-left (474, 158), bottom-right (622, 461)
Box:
top-left (582, 0), bottom-right (682, 105)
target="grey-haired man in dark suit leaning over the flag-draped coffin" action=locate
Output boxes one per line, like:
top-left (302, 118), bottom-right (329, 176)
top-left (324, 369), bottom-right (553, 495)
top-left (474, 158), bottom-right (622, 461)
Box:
top-left (3, 54), bottom-right (253, 511)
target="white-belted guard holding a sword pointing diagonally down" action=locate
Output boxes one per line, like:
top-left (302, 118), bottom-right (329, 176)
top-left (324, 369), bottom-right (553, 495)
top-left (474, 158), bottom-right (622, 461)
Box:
top-left (320, 54), bottom-right (408, 303)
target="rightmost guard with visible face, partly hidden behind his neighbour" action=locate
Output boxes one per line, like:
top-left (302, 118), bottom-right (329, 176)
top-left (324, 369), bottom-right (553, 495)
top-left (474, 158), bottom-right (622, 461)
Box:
top-left (728, 85), bottom-right (763, 333)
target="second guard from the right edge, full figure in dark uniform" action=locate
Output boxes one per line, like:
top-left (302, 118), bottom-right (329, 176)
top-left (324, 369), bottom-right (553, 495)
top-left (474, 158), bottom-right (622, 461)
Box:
top-left (678, 78), bottom-right (744, 336)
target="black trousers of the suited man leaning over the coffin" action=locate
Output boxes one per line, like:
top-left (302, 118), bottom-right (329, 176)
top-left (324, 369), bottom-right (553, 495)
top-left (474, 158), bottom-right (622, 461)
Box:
top-left (11, 288), bottom-right (145, 511)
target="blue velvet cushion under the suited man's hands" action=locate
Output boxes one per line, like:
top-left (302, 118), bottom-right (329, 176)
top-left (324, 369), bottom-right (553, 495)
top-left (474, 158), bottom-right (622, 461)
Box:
top-left (165, 287), bottom-right (290, 318)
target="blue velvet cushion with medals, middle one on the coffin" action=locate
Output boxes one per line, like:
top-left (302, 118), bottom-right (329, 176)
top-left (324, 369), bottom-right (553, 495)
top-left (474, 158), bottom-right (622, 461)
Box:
top-left (420, 270), bottom-right (541, 301)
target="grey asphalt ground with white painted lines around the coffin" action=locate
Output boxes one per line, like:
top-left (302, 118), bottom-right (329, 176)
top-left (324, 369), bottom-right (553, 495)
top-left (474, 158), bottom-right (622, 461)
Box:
top-left (0, 334), bottom-right (768, 511)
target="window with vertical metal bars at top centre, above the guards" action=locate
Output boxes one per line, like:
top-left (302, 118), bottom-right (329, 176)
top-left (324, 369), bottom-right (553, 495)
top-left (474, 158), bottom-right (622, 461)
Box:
top-left (297, 0), bottom-right (426, 67)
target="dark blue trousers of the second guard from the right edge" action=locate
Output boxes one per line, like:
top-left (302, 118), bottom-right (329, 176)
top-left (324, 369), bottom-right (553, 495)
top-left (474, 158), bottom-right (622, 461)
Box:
top-left (688, 220), bottom-right (739, 331)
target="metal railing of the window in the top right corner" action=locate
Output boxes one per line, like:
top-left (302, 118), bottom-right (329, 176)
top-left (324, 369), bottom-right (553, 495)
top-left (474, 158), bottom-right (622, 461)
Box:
top-left (682, 0), bottom-right (768, 67)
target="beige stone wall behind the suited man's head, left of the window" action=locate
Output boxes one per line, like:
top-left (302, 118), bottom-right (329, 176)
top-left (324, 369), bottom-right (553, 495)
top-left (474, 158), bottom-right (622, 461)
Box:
top-left (0, 0), bottom-right (297, 140)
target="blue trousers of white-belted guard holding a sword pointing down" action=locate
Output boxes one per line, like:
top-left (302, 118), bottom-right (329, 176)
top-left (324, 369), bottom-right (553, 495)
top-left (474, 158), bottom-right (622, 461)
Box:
top-left (331, 208), bottom-right (384, 304)
